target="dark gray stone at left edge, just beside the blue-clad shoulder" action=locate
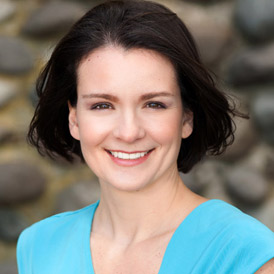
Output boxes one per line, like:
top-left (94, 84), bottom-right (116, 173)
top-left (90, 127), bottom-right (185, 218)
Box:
top-left (0, 209), bottom-right (28, 241)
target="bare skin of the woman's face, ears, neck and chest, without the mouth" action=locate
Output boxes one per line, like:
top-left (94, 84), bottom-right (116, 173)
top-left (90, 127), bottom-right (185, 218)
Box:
top-left (69, 45), bottom-right (272, 274)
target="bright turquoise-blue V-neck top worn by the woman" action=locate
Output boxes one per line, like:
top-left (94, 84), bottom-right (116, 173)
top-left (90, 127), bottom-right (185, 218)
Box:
top-left (17, 200), bottom-right (274, 274)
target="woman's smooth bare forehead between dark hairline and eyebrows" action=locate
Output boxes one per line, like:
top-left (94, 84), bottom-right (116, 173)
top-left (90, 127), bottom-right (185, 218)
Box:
top-left (77, 46), bottom-right (180, 94)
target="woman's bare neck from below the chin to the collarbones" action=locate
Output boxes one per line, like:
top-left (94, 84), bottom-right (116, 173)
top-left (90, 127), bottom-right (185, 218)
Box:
top-left (92, 168), bottom-right (201, 245)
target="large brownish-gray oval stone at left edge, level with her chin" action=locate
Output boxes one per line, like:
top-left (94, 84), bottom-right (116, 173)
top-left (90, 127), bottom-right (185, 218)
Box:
top-left (0, 161), bottom-right (46, 204)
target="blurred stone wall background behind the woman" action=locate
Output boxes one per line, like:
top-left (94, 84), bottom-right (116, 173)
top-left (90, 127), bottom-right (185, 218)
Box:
top-left (0, 0), bottom-right (274, 274)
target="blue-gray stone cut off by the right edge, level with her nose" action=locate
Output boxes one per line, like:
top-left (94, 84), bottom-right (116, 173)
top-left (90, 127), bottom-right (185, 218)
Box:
top-left (251, 88), bottom-right (274, 145)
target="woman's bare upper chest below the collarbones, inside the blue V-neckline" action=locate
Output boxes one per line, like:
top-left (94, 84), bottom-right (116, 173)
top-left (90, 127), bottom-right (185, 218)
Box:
top-left (91, 233), bottom-right (172, 274)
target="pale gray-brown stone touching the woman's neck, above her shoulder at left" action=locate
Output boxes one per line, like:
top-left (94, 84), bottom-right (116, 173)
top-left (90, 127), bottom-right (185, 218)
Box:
top-left (54, 180), bottom-right (100, 213)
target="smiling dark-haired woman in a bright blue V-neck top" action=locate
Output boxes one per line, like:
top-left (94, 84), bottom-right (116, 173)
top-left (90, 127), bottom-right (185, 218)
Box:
top-left (17, 1), bottom-right (274, 274)
